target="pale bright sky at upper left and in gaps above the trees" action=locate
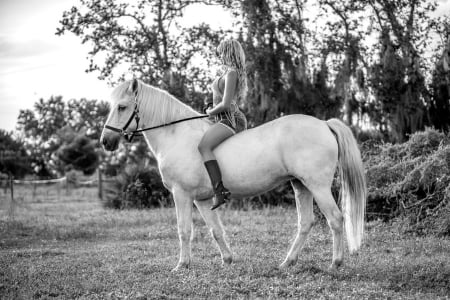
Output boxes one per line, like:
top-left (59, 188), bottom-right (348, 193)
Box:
top-left (0, 0), bottom-right (450, 131)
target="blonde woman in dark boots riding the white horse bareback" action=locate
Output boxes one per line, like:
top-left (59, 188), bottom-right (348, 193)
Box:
top-left (198, 39), bottom-right (247, 210)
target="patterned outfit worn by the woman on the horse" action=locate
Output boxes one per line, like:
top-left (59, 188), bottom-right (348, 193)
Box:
top-left (211, 72), bottom-right (247, 132)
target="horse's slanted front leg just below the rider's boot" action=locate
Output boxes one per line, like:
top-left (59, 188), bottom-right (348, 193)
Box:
top-left (194, 201), bottom-right (233, 264)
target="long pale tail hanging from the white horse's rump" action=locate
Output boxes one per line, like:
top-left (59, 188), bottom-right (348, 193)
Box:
top-left (327, 119), bottom-right (367, 252)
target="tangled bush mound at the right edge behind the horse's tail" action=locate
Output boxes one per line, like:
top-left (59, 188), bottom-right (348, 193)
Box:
top-left (362, 129), bottom-right (450, 235)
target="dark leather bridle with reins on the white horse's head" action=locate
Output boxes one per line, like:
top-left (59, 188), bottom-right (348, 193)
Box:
top-left (105, 89), bottom-right (209, 143)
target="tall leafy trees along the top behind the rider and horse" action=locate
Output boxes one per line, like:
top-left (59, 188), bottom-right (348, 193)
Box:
top-left (57, 0), bottom-right (450, 142)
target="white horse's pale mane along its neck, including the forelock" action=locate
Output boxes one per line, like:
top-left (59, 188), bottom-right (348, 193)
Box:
top-left (112, 81), bottom-right (199, 127)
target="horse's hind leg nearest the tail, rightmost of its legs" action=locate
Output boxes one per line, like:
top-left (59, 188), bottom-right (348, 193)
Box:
top-left (312, 186), bottom-right (344, 269)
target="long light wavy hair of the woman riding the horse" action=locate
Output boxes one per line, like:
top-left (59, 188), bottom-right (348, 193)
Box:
top-left (216, 39), bottom-right (248, 104)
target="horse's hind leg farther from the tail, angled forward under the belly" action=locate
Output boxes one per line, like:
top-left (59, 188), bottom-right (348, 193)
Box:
top-left (280, 179), bottom-right (314, 268)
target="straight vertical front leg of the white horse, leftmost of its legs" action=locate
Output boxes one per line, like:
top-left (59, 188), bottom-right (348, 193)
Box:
top-left (172, 190), bottom-right (193, 271)
